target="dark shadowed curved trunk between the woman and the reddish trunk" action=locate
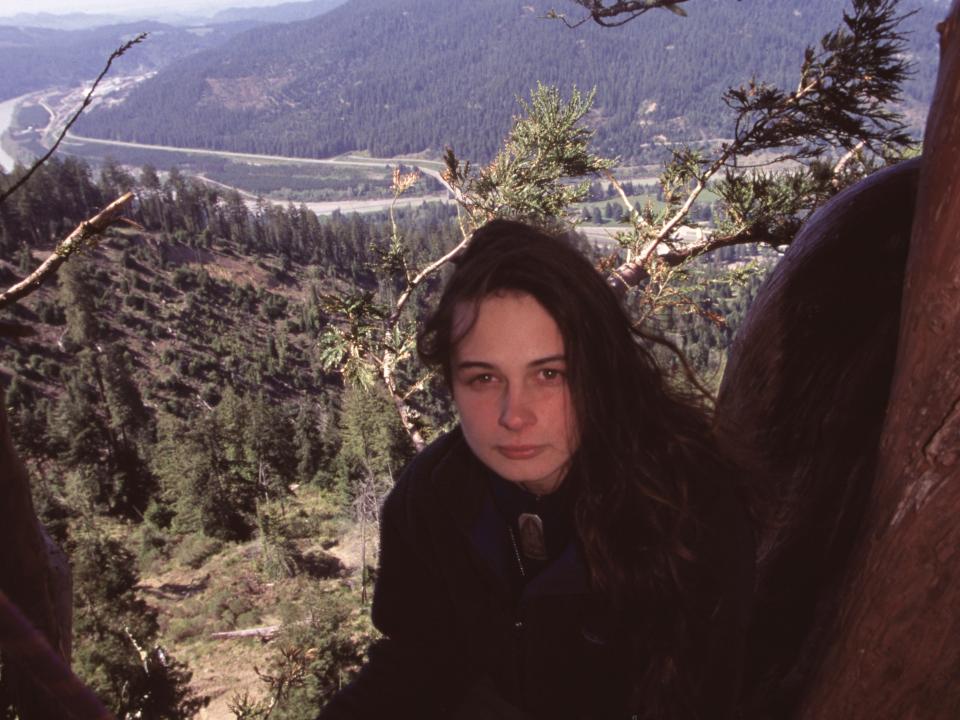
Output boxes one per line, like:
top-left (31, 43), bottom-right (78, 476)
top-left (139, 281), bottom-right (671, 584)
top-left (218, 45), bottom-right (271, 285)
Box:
top-left (716, 161), bottom-right (920, 720)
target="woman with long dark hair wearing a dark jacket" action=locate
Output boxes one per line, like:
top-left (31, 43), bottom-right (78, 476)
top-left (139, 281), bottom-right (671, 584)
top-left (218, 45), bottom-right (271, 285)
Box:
top-left (323, 220), bottom-right (753, 720)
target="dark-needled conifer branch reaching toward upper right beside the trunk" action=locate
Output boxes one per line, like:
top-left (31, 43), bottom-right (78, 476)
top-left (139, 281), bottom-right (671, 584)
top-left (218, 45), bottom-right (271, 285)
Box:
top-left (604, 0), bottom-right (910, 292)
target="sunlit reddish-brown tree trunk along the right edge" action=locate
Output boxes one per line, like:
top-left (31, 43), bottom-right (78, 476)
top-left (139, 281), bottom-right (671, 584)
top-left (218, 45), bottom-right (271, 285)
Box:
top-left (800, 0), bottom-right (960, 720)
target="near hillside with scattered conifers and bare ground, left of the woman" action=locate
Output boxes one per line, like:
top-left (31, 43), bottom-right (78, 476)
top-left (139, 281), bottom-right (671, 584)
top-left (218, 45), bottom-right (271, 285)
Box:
top-left (0, 160), bottom-right (455, 717)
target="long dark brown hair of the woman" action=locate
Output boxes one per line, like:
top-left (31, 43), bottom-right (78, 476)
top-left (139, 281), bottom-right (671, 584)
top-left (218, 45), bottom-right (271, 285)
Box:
top-left (418, 220), bottom-right (740, 718)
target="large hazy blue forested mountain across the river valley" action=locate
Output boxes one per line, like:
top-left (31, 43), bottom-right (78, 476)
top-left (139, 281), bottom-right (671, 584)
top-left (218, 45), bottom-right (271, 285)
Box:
top-left (73, 0), bottom-right (940, 159)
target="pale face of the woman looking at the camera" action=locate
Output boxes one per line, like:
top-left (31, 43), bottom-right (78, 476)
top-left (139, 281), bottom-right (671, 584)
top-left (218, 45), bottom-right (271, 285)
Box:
top-left (451, 293), bottom-right (578, 495)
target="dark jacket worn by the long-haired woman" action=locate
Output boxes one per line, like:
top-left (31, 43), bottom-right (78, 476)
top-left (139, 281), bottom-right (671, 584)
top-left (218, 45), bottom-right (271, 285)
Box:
top-left (321, 430), bottom-right (753, 720)
